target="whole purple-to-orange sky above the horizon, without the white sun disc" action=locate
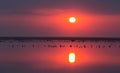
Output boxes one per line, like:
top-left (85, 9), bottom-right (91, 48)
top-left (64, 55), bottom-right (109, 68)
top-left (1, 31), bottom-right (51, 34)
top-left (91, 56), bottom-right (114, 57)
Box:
top-left (0, 0), bottom-right (120, 37)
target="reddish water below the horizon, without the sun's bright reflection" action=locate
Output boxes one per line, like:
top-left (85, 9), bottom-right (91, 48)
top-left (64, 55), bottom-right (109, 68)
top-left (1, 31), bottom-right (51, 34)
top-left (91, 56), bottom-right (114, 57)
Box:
top-left (0, 37), bottom-right (120, 73)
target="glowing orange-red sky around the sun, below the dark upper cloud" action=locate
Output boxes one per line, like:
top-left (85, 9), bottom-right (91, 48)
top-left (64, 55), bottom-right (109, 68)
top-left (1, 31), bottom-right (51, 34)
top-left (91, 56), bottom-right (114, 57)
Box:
top-left (0, 9), bottom-right (120, 37)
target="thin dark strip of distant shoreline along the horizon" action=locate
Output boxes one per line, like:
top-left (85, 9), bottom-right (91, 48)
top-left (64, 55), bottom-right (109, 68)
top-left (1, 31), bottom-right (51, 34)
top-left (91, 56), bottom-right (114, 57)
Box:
top-left (0, 37), bottom-right (120, 41)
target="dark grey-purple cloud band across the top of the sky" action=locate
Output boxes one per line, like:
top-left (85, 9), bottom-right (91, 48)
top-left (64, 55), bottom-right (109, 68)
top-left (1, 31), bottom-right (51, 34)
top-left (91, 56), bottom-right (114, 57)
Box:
top-left (0, 0), bottom-right (120, 14)
